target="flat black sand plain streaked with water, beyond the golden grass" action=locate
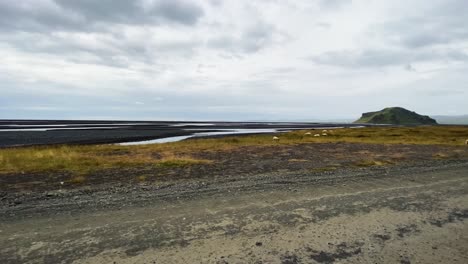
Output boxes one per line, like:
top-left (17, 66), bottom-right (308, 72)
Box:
top-left (0, 120), bottom-right (366, 147)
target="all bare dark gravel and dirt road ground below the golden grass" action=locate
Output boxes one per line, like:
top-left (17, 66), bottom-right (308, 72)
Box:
top-left (0, 139), bottom-right (468, 264)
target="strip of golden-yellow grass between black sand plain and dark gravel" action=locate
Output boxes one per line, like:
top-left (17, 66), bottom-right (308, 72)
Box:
top-left (0, 126), bottom-right (468, 175)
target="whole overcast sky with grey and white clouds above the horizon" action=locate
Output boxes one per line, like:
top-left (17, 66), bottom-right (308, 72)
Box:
top-left (0, 0), bottom-right (468, 121)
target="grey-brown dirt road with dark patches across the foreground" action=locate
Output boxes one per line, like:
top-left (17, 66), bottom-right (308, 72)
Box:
top-left (0, 163), bottom-right (468, 264)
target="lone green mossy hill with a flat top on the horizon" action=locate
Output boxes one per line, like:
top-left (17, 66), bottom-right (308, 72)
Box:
top-left (354, 107), bottom-right (437, 125)
